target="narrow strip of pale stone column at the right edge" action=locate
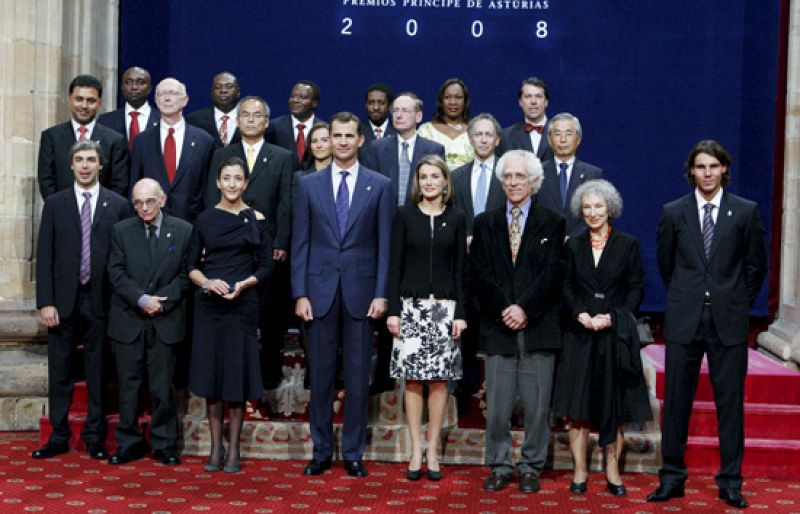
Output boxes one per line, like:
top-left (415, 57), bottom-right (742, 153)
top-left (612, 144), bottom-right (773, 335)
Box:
top-left (758, 0), bottom-right (800, 364)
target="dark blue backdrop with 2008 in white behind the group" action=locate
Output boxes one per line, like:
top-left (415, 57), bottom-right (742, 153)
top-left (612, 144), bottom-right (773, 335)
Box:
top-left (120, 0), bottom-right (780, 315)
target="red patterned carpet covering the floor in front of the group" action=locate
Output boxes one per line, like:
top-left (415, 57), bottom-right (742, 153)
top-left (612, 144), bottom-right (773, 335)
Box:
top-left (0, 433), bottom-right (800, 514)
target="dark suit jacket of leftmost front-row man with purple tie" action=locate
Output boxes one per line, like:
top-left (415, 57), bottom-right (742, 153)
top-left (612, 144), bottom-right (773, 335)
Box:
top-left (36, 186), bottom-right (131, 318)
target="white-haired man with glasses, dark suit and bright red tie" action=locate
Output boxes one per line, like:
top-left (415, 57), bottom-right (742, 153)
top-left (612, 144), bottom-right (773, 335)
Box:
top-left (131, 78), bottom-right (214, 223)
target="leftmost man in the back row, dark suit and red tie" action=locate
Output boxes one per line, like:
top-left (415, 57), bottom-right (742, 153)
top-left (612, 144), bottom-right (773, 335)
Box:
top-left (97, 66), bottom-right (161, 151)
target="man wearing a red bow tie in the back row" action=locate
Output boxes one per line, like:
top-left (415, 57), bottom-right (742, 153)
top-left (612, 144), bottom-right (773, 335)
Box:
top-left (498, 77), bottom-right (553, 162)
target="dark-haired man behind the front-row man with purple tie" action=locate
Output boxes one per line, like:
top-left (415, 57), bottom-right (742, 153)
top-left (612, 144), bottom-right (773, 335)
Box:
top-left (37, 75), bottom-right (129, 200)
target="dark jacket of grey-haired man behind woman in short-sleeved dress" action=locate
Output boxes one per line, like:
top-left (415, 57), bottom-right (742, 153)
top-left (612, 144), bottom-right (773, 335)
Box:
top-left (205, 141), bottom-right (293, 250)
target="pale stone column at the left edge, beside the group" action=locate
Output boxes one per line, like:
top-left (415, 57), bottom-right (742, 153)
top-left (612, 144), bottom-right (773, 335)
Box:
top-left (0, 0), bottom-right (119, 430)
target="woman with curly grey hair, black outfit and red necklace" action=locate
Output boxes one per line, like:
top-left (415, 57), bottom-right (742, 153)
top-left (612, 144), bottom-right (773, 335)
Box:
top-left (553, 180), bottom-right (651, 496)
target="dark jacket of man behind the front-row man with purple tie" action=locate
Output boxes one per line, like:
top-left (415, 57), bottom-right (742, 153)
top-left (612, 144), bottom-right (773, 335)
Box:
top-left (38, 121), bottom-right (129, 200)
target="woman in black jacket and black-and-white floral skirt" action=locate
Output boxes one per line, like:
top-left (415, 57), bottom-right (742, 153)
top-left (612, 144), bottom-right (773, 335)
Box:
top-left (386, 155), bottom-right (467, 480)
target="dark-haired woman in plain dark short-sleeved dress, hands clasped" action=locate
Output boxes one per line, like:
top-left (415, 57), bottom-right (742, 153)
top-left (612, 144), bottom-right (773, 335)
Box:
top-left (189, 157), bottom-right (274, 473)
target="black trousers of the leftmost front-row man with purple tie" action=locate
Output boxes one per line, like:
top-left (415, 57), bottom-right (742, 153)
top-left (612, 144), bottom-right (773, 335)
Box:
top-left (47, 285), bottom-right (108, 445)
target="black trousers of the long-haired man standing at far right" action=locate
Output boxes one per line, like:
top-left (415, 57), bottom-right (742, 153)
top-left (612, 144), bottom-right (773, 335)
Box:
top-left (659, 306), bottom-right (747, 489)
